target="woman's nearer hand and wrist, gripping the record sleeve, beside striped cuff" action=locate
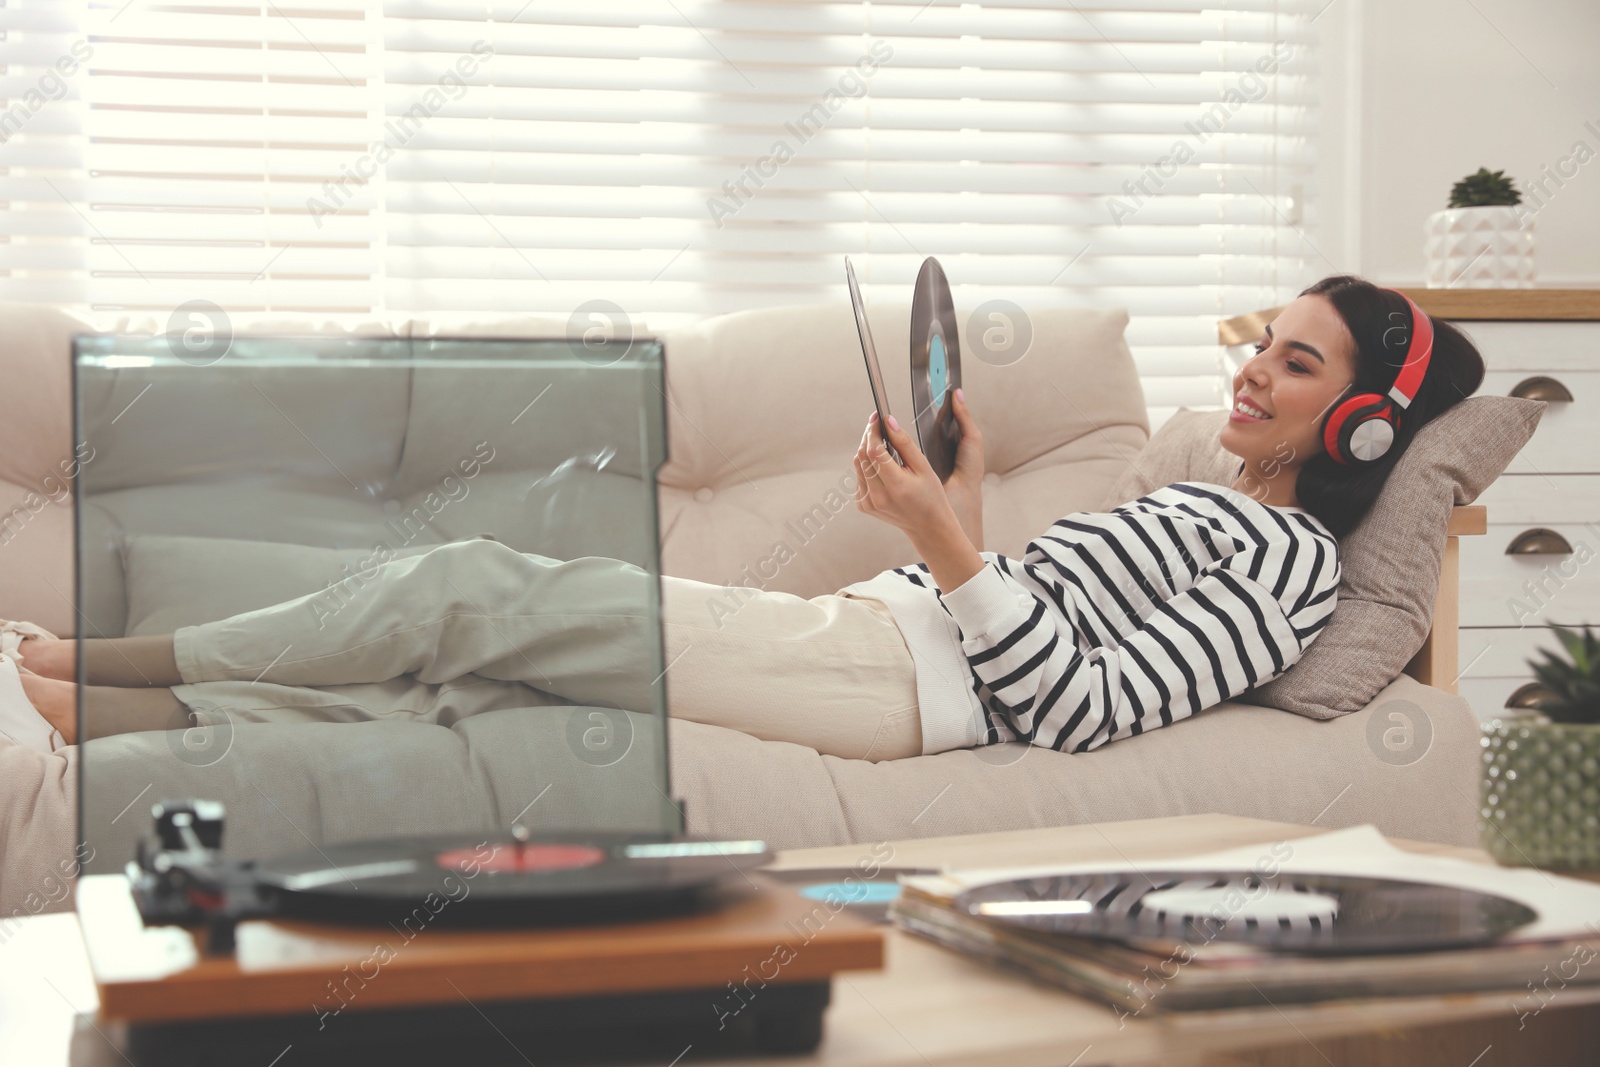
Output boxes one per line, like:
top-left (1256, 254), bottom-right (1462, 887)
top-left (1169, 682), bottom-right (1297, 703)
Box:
top-left (854, 411), bottom-right (984, 592)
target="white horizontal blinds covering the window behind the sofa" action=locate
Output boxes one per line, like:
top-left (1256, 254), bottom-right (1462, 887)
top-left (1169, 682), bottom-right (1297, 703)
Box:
top-left (0, 0), bottom-right (1328, 424)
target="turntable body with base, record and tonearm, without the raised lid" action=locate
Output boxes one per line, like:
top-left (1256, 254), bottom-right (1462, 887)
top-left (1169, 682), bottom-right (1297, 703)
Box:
top-left (78, 801), bottom-right (883, 1067)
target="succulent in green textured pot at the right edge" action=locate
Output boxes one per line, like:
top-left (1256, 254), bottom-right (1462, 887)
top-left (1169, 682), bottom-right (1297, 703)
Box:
top-left (1478, 622), bottom-right (1600, 870)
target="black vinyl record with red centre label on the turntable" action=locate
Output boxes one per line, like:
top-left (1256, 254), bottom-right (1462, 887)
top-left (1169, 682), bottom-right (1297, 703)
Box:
top-left (254, 833), bottom-right (771, 925)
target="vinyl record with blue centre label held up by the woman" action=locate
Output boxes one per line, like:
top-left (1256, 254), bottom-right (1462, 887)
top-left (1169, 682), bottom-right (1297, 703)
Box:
top-left (910, 256), bottom-right (962, 482)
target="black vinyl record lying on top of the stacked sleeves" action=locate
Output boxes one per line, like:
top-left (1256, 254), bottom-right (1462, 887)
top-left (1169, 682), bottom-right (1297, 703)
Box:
top-left (955, 870), bottom-right (1538, 955)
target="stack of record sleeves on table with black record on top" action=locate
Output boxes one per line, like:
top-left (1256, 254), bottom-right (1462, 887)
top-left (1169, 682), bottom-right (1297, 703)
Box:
top-left (891, 844), bottom-right (1600, 1014)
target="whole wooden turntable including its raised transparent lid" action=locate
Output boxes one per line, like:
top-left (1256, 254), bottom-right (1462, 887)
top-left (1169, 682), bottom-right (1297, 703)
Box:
top-left (74, 336), bottom-right (883, 1067)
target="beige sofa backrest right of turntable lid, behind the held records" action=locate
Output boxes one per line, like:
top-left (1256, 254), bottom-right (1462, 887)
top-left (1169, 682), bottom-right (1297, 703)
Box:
top-left (661, 302), bottom-right (1149, 597)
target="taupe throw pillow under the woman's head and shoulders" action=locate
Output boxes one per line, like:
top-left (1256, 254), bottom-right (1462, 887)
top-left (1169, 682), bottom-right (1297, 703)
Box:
top-left (1102, 397), bottom-right (1547, 718)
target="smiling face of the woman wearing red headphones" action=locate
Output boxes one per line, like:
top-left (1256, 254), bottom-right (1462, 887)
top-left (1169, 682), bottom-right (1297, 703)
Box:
top-left (1219, 296), bottom-right (1355, 478)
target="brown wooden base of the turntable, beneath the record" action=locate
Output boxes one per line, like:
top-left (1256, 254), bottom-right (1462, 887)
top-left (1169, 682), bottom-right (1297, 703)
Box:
top-left (77, 872), bottom-right (883, 1067)
